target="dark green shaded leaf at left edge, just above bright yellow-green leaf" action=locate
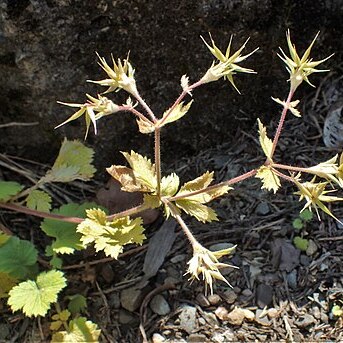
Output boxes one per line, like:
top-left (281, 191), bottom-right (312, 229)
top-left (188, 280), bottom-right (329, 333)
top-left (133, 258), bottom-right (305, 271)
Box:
top-left (0, 236), bottom-right (38, 279)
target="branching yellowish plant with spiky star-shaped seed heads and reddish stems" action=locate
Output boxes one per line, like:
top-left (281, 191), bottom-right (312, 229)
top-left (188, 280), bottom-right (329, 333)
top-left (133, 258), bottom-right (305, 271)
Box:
top-left (1, 32), bottom-right (343, 298)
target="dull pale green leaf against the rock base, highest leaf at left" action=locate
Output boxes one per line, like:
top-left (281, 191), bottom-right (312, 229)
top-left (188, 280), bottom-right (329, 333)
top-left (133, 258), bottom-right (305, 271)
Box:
top-left (43, 139), bottom-right (95, 182)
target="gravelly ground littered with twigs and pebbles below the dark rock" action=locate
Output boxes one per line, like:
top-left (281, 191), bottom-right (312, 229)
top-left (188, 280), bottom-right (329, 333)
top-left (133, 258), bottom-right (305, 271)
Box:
top-left (0, 66), bottom-right (343, 343)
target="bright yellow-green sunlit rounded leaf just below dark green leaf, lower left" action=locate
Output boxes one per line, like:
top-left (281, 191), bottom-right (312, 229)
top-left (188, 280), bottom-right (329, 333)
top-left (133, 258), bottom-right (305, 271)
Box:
top-left (8, 270), bottom-right (67, 317)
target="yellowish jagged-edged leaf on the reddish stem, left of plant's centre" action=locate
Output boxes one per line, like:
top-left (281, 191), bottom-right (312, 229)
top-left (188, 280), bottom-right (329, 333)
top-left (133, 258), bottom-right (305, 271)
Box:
top-left (77, 209), bottom-right (145, 259)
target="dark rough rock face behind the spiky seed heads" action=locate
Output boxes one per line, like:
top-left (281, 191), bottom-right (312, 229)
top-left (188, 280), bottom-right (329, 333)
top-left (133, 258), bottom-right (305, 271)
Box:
top-left (0, 0), bottom-right (343, 175)
